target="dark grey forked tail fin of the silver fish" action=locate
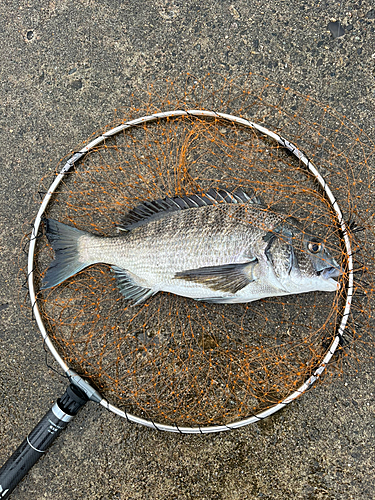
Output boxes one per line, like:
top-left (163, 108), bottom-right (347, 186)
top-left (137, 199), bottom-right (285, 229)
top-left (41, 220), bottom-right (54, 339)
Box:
top-left (41, 219), bottom-right (92, 290)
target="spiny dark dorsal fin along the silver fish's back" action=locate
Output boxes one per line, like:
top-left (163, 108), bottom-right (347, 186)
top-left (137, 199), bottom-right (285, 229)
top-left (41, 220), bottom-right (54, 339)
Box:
top-left (117, 188), bottom-right (264, 231)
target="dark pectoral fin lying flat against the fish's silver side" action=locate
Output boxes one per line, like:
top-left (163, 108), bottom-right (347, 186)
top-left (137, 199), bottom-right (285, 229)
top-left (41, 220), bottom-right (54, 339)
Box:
top-left (174, 258), bottom-right (258, 293)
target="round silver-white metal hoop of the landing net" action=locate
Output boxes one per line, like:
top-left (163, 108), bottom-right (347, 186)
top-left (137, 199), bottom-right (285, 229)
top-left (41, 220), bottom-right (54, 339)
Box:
top-left (28, 109), bottom-right (354, 434)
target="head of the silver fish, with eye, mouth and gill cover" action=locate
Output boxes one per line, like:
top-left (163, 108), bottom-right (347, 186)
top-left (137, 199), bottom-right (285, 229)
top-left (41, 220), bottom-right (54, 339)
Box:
top-left (268, 221), bottom-right (342, 293)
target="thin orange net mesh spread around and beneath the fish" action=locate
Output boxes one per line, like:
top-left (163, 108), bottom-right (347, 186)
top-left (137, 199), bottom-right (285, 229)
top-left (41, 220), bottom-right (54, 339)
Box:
top-left (28, 75), bottom-right (374, 425)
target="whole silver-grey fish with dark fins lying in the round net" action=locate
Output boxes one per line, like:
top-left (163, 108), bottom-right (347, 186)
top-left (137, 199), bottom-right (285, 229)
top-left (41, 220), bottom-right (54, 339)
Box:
top-left (41, 188), bottom-right (342, 305)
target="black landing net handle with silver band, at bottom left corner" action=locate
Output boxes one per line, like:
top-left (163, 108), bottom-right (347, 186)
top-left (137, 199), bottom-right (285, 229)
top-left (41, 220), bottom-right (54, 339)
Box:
top-left (0, 384), bottom-right (88, 500)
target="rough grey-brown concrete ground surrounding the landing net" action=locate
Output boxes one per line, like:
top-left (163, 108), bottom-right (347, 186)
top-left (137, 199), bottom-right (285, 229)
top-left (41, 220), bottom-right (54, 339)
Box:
top-left (0, 0), bottom-right (375, 500)
